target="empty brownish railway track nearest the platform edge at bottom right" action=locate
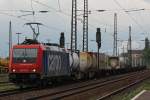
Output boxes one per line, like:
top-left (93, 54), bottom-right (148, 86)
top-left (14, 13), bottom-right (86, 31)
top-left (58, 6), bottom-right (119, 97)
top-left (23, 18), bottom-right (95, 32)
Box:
top-left (28, 71), bottom-right (150, 100)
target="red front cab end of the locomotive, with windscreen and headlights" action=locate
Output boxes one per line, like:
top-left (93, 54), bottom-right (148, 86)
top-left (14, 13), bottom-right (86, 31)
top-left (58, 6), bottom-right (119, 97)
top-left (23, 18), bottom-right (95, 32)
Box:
top-left (9, 44), bottom-right (42, 83)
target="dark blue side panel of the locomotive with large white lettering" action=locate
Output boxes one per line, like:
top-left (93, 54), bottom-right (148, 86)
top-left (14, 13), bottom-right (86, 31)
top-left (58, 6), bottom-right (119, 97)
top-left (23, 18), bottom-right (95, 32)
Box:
top-left (43, 51), bottom-right (71, 77)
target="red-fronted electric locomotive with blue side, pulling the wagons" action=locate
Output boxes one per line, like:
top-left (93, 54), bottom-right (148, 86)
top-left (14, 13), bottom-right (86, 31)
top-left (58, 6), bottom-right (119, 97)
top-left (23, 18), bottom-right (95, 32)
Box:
top-left (9, 39), bottom-right (71, 85)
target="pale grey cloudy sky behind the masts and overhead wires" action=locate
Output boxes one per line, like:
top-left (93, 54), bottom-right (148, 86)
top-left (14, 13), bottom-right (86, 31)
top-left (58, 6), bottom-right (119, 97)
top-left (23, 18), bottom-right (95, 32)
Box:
top-left (0, 0), bottom-right (150, 57)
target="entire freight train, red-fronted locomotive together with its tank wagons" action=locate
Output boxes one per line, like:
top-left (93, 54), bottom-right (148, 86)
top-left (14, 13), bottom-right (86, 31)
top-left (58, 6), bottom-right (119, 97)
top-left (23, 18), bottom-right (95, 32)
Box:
top-left (9, 39), bottom-right (144, 85)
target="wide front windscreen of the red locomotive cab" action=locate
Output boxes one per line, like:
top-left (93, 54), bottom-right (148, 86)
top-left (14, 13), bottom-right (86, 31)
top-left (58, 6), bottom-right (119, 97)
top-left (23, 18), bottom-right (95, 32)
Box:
top-left (13, 48), bottom-right (37, 63)
